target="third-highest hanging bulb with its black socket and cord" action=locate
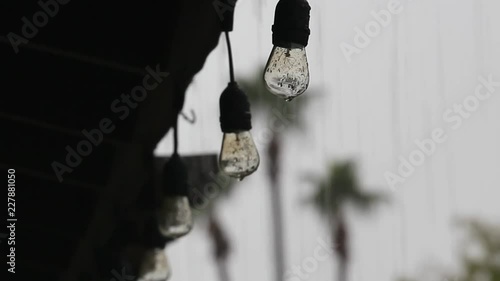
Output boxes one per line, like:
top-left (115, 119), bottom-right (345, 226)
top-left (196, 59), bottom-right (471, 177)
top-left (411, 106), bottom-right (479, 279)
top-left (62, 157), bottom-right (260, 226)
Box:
top-left (158, 137), bottom-right (193, 236)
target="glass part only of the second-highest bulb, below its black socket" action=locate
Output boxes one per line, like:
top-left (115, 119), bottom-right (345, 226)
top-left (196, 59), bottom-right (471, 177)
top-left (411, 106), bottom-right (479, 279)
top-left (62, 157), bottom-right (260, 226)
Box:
top-left (219, 131), bottom-right (260, 180)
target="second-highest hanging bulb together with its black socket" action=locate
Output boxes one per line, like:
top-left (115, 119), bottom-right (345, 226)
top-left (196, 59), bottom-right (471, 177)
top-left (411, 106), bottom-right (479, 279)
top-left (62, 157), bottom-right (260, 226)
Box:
top-left (219, 82), bottom-right (260, 180)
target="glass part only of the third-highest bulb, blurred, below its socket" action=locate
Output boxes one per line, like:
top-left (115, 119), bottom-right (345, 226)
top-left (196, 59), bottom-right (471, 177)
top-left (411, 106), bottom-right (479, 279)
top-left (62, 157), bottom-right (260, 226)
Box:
top-left (158, 196), bottom-right (193, 238)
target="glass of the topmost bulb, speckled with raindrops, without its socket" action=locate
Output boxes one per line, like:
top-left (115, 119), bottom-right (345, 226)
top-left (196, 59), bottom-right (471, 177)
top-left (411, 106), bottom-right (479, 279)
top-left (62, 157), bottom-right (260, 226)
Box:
top-left (264, 44), bottom-right (309, 101)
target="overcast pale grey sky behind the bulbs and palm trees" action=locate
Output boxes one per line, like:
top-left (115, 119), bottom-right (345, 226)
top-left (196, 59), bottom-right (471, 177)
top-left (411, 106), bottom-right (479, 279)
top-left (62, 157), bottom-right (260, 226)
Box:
top-left (157, 0), bottom-right (500, 281)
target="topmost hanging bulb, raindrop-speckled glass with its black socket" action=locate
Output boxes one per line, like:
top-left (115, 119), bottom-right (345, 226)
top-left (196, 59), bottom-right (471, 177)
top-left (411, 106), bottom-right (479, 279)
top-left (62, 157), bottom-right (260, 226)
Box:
top-left (264, 0), bottom-right (311, 101)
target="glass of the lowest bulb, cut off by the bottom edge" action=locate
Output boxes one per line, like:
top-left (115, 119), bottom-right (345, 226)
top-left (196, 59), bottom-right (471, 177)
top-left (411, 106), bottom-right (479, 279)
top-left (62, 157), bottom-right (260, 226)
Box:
top-left (137, 248), bottom-right (172, 281)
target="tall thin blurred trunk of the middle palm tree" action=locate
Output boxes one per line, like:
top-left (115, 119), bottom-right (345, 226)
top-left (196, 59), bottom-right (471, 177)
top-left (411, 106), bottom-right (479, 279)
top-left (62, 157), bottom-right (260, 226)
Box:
top-left (267, 134), bottom-right (285, 281)
